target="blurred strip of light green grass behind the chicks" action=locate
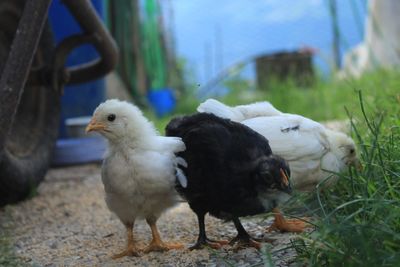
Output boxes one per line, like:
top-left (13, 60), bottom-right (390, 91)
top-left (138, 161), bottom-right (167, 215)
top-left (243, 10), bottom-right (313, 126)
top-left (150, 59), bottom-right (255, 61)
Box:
top-left (145, 71), bottom-right (400, 132)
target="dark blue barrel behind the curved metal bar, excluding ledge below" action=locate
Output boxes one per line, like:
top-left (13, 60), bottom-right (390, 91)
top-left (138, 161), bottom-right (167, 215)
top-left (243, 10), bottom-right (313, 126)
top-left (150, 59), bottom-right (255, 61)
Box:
top-left (49, 0), bottom-right (105, 138)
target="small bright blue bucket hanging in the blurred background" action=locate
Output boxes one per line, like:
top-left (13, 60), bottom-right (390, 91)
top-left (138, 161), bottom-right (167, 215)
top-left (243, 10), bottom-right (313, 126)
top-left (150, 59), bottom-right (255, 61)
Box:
top-left (147, 88), bottom-right (176, 117)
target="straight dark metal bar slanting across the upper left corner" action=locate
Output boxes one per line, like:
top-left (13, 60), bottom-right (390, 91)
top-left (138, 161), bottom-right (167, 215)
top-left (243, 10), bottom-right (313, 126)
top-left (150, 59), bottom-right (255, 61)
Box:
top-left (0, 0), bottom-right (51, 155)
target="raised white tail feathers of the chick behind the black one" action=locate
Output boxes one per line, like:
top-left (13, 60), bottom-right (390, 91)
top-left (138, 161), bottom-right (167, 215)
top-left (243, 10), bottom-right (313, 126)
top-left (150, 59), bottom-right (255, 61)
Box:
top-left (197, 98), bottom-right (246, 122)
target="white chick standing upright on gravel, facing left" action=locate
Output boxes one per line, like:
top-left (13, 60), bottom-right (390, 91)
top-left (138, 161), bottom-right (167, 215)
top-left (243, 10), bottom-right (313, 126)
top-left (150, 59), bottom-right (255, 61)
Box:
top-left (86, 99), bottom-right (187, 258)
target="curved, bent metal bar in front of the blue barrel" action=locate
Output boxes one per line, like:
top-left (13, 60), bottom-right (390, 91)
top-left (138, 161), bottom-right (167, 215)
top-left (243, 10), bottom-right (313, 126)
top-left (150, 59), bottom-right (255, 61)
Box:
top-left (59, 0), bottom-right (118, 84)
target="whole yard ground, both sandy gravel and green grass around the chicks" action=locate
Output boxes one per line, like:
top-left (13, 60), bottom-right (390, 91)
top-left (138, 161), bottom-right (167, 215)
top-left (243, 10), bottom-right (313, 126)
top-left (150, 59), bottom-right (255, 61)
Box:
top-left (0, 68), bottom-right (400, 266)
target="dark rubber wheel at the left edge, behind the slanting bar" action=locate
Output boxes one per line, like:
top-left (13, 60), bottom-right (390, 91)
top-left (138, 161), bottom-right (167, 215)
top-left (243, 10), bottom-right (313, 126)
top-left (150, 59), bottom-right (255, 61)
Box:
top-left (0, 0), bottom-right (61, 206)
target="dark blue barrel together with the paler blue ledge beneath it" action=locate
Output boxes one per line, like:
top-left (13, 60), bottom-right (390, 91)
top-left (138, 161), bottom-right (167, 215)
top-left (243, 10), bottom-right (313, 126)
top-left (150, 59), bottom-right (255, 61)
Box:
top-left (49, 0), bottom-right (106, 166)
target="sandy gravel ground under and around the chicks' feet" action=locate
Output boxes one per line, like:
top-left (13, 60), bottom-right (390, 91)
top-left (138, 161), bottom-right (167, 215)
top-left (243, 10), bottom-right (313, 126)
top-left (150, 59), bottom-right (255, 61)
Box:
top-left (0, 164), bottom-right (295, 266)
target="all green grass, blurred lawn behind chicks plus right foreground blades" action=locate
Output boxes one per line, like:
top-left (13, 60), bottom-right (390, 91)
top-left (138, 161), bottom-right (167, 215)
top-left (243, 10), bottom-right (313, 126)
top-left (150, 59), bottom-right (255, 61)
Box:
top-left (148, 71), bottom-right (400, 267)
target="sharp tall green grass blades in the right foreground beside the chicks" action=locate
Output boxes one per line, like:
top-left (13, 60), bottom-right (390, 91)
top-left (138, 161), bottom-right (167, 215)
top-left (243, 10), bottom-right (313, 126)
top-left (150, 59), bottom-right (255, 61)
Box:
top-left (295, 93), bottom-right (400, 266)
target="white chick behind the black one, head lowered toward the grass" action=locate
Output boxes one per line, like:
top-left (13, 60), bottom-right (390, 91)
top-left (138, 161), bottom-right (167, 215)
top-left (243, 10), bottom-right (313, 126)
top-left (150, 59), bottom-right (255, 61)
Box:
top-left (197, 99), bottom-right (361, 231)
